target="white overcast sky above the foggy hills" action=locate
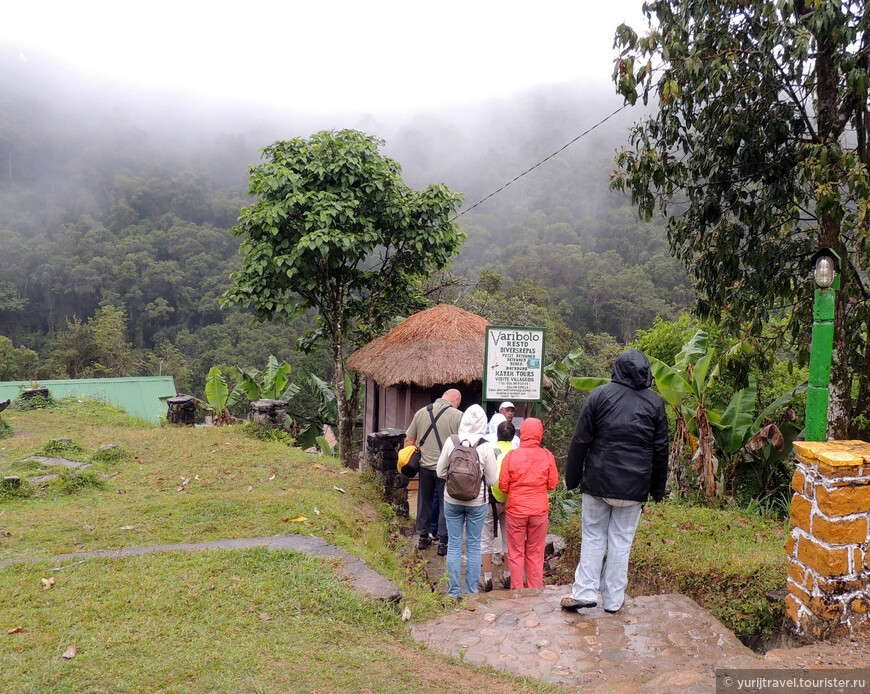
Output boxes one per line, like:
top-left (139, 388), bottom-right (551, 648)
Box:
top-left (0, 0), bottom-right (643, 114)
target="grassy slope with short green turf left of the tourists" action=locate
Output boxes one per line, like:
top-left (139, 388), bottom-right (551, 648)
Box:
top-left (0, 403), bottom-right (560, 693)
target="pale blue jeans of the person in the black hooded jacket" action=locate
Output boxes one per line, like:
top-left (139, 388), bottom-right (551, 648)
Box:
top-left (571, 494), bottom-right (643, 610)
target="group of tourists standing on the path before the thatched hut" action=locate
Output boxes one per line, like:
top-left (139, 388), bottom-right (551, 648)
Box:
top-left (405, 349), bottom-right (668, 612)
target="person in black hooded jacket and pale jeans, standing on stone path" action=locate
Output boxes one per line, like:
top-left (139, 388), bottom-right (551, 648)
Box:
top-left (562, 349), bottom-right (668, 612)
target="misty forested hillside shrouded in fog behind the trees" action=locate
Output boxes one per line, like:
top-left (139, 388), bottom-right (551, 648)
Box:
top-left (0, 44), bottom-right (691, 396)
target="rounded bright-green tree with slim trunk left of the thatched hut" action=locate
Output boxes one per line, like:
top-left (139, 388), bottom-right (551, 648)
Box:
top-left (223, 130), bottom-right (465, 466)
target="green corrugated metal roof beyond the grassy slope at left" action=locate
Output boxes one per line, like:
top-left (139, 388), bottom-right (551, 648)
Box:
top-left (0, 376), bottom-right (175, 424)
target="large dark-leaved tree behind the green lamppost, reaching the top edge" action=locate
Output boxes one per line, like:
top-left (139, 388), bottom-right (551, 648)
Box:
top-left (612, 0), bottom-right (870, 438)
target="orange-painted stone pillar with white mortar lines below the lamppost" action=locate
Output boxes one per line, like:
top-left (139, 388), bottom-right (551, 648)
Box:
top-left (785, 441), bottom-right (870, 641)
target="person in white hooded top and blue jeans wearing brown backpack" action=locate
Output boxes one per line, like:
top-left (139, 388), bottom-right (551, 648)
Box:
top-left (436, 405), bottom-right (498, 598)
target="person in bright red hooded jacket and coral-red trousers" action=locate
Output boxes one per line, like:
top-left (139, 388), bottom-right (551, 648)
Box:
top-left (498, 417), bottom-right (559, 590)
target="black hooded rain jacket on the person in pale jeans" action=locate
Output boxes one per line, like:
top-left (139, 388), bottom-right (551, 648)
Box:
top-left (565, 349), bottom-right (668, 501)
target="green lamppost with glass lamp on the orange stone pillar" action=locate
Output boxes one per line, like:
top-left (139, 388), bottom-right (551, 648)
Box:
top-left (805, 248), bottom-right (840, 441)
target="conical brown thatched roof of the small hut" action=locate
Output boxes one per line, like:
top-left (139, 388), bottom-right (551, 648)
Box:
top-left (347, 304), bottom-right (489, 388)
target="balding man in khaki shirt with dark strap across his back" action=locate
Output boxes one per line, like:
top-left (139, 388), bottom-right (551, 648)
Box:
top-left (405, 388), bottom-right (462, 556)
